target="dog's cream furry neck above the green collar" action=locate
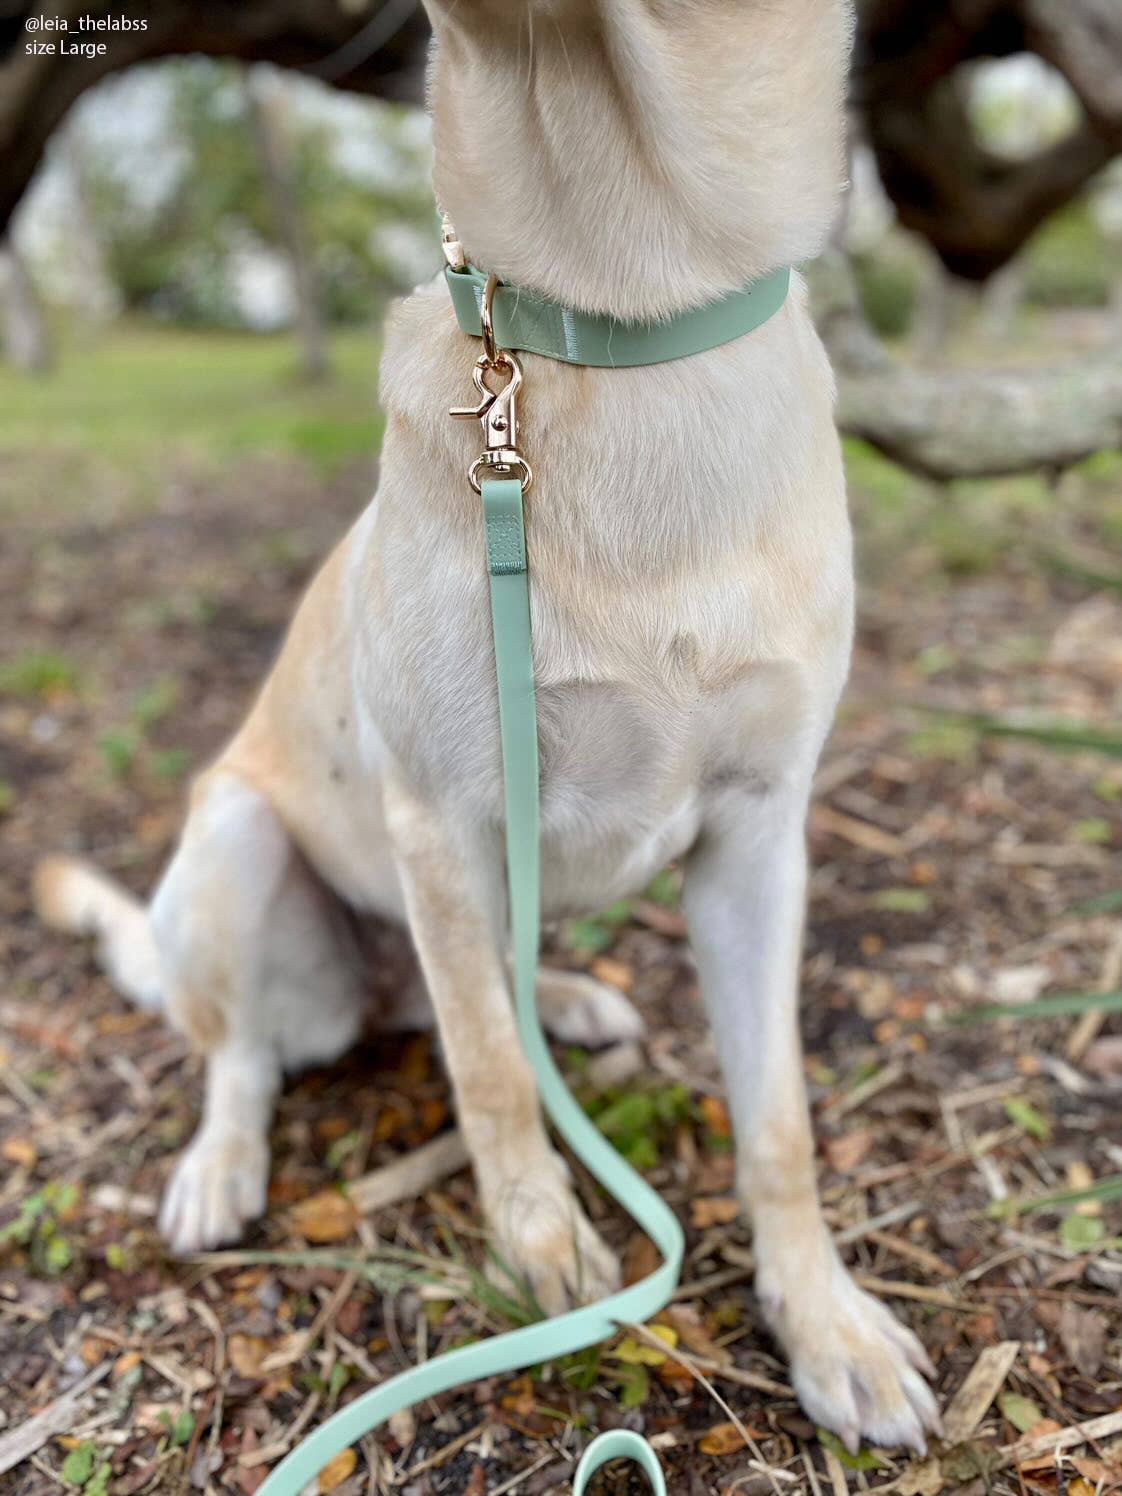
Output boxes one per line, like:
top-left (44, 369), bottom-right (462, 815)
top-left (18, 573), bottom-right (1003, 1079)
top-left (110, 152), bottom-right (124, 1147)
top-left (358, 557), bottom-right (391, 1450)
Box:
top-left (426, 0), bottom-right (851, 319)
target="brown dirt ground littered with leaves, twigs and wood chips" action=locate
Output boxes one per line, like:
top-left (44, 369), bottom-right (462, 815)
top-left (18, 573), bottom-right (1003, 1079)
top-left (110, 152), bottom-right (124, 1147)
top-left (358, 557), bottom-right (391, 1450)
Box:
top-left (0, 459), bottom-right (1122, 1496)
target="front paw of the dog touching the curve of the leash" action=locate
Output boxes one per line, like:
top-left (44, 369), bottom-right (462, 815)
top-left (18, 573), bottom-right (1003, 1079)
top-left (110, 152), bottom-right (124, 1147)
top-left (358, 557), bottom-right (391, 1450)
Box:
top-left (489, 1159), bottom-right (619, 1315)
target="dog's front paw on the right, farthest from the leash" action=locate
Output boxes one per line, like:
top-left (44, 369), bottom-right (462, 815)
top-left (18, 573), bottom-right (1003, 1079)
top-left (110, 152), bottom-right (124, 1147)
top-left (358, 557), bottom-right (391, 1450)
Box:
top-left (758, 1260), bottom-right (942, 1454)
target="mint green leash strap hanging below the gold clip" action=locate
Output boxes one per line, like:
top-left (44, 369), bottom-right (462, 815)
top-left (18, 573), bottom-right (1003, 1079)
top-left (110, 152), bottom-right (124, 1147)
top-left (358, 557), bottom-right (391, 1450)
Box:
top-left (259, 479), bottom-right (685, 1496)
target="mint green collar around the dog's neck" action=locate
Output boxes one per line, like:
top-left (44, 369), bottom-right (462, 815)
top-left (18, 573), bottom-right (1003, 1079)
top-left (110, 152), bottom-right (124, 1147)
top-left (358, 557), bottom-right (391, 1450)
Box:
top-left (444, 265), bottom-right (791, 368)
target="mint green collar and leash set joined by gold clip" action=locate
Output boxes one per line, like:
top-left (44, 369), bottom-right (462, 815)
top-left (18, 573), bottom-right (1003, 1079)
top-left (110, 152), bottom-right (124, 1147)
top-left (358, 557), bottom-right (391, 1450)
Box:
top-left (259, 265), bottom-right (790, 1496)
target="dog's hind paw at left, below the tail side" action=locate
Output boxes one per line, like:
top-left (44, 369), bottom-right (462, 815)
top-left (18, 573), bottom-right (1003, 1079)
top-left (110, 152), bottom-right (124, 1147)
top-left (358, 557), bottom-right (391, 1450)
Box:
top-left (160, 1132), bottom-right (269, 1254)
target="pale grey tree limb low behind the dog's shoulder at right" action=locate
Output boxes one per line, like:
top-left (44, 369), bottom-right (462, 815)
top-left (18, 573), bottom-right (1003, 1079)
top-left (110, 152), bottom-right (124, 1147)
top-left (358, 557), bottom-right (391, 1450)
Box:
top-left (812, 253), bottom-right (1122, 480)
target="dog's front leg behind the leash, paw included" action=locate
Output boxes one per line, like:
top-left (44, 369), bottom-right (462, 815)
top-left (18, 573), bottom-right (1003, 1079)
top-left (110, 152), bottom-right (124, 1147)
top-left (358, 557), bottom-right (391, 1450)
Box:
top-left (386, 782), bottom-right (618, 1313)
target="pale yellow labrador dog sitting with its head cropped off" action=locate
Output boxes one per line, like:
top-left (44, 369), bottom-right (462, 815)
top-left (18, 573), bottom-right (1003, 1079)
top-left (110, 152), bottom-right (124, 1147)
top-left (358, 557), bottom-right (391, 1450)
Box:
top-left (39, 0), bottom-right (938, 1448)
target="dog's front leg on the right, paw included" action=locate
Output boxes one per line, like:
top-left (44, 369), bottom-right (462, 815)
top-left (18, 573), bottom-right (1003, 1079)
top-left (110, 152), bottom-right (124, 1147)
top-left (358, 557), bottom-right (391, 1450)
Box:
top-left (685, 785), bottom-right (939, 1450)
